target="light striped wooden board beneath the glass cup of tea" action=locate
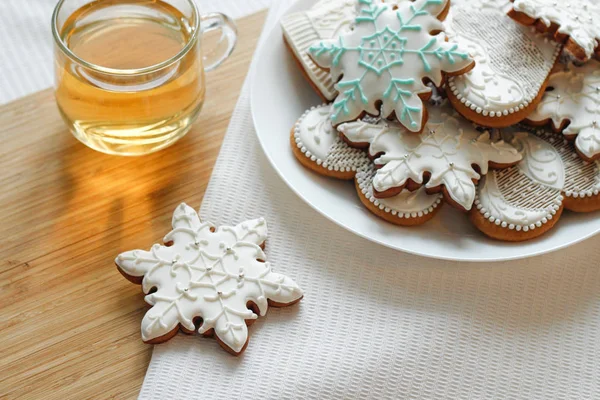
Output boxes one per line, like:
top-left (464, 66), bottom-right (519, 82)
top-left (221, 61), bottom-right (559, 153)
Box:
top-left (0, 12), bottom-right (265, 399)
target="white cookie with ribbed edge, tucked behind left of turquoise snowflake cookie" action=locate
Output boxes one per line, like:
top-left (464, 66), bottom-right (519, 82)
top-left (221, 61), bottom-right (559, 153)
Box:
top-left (281, 0), bottom-right (409, 101)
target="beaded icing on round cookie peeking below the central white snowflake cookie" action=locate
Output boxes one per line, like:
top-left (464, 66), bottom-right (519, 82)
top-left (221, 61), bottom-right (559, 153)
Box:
top-left (356, 163), bottom-right (443, 219)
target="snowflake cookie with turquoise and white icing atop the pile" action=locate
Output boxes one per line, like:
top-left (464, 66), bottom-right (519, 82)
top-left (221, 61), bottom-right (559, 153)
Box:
top-left (308, 0), bottom-right (475, 132)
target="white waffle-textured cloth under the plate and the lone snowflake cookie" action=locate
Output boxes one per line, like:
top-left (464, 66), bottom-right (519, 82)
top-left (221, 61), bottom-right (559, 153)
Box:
top-left (140, 1), bottom-right (600, 400)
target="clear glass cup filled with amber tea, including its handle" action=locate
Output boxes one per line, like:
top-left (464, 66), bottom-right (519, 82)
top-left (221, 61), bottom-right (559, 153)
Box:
top-left (52, 0), bottom-right (237, 155)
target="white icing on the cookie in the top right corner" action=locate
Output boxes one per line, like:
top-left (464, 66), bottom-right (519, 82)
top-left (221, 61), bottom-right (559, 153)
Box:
top-left (513, 0), bottom-right (600, 59)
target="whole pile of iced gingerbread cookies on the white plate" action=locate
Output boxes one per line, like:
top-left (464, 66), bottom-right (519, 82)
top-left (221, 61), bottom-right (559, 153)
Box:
top-left (282, 0), bottom-right (600, 241)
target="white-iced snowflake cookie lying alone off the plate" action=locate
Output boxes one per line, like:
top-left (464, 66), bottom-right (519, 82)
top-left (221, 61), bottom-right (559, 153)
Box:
top-left (115, 203), bottom-right (303, 355)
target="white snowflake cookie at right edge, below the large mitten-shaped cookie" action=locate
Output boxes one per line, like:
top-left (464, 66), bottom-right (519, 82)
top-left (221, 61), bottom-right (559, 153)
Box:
top-left (526, 60), bottom-right (600, 161)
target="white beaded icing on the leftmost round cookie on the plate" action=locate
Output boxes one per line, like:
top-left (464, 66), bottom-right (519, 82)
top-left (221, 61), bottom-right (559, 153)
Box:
top-left (294, 104), bottom-right (369, 172)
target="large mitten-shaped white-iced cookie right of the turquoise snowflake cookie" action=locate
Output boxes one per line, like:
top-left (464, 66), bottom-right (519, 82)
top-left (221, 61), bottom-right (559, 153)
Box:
top-left (444, 0), bottom-right (561, 127)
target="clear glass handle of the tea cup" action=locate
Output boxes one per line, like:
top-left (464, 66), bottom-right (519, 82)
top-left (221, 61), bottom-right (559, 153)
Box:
top-left (200, 13), bottom-right (237, 71)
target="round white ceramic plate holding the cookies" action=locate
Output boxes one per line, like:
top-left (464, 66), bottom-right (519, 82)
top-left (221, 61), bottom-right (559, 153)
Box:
top-left (251, 0), bottom-right (600, 261)
